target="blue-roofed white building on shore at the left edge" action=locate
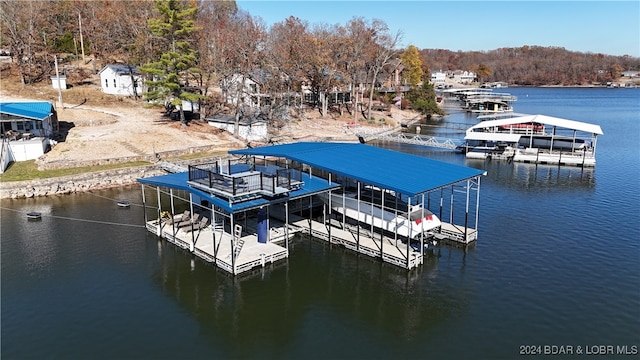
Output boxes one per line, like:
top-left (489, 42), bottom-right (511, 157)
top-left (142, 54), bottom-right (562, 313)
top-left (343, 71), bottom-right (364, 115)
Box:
top-left (0, 101), bottom-right (59, 173)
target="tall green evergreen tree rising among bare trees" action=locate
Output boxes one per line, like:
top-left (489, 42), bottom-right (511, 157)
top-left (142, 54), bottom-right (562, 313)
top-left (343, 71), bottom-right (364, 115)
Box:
top-left (140, 0), bottom-right (204, 125)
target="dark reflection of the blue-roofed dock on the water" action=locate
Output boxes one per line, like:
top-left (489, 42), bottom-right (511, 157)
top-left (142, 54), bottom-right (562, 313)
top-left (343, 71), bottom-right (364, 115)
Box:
top-left (154, 232), bottom-right (470, 355)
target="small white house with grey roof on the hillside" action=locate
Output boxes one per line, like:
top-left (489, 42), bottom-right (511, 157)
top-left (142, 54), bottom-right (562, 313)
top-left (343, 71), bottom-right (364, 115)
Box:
top-left (100, 64), bottom-right (144, 96)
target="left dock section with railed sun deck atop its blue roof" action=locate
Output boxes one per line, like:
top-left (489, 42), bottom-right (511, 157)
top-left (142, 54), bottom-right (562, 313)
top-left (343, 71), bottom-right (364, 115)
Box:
top-left (138, 160), bottom-right (336, 275)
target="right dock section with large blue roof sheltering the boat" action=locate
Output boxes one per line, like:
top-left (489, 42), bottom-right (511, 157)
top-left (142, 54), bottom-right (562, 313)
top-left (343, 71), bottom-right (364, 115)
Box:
top-left (230, 142), bottom-right (485, 269)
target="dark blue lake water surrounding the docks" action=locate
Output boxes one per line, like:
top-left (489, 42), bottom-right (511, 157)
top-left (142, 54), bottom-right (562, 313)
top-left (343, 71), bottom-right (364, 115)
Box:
top-left (0, 88), bottom-right (640, 359)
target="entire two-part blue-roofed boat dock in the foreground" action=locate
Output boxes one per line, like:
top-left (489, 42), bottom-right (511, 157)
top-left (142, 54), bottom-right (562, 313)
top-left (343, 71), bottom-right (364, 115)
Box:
top-left (138, 143), bottom-right (484, 275)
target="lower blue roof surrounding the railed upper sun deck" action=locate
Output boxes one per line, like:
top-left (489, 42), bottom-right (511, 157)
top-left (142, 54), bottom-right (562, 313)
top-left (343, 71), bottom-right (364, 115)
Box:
top-left (138, 172), bottom-right (338, 213)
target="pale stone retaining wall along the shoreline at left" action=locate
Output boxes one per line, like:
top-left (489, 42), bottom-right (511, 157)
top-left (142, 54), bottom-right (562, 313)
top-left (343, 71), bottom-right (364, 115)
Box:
top-left (0, 165), bottom-right (166, 199)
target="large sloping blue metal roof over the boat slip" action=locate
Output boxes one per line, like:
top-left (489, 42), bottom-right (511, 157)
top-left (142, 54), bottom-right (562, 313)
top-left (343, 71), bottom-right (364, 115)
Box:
top-left (229, 142), bottom-right (484, 196)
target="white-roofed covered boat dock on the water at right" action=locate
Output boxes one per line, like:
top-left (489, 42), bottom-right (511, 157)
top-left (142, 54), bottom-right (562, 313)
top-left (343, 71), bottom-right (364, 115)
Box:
top-left (458, 115), bottom-right (603, 166)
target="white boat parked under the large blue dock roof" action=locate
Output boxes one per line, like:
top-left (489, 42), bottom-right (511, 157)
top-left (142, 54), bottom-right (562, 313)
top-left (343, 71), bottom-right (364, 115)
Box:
top-left (319, 187), bottom-right (442, 239)
